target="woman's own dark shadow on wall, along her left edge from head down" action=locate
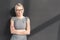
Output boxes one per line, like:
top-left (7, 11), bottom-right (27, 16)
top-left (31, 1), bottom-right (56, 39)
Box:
top-left (4, 7), bottom-right (16, 40)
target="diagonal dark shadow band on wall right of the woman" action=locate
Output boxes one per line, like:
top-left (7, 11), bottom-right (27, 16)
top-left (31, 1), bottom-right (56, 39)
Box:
top-left (28, 14), bottom-right (60, 40)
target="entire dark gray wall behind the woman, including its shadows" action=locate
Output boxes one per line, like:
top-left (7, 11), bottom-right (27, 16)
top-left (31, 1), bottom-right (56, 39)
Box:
top-left (0, 0), bottom-right (60, 40)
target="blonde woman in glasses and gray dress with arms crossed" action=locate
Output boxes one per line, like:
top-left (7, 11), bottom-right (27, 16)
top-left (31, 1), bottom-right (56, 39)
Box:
top-left (10, 3), bottom-right (30, 40)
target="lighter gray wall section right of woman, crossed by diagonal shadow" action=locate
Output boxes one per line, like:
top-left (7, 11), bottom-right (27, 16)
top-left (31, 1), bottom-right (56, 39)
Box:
top-left (29, 0), bottom-right (60, 40)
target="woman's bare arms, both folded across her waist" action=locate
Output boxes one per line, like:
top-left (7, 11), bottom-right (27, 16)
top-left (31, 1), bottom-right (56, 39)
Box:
top-left (10, 19), bottom-right (30, 35)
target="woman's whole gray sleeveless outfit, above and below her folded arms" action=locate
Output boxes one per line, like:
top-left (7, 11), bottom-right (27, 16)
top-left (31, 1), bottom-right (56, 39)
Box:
top-left (10, 17), bottom-right (27, 40)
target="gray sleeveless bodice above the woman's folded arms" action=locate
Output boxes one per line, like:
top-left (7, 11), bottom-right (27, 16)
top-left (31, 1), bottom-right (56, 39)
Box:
top-left (12, 17), bottom-right (27, 29)
